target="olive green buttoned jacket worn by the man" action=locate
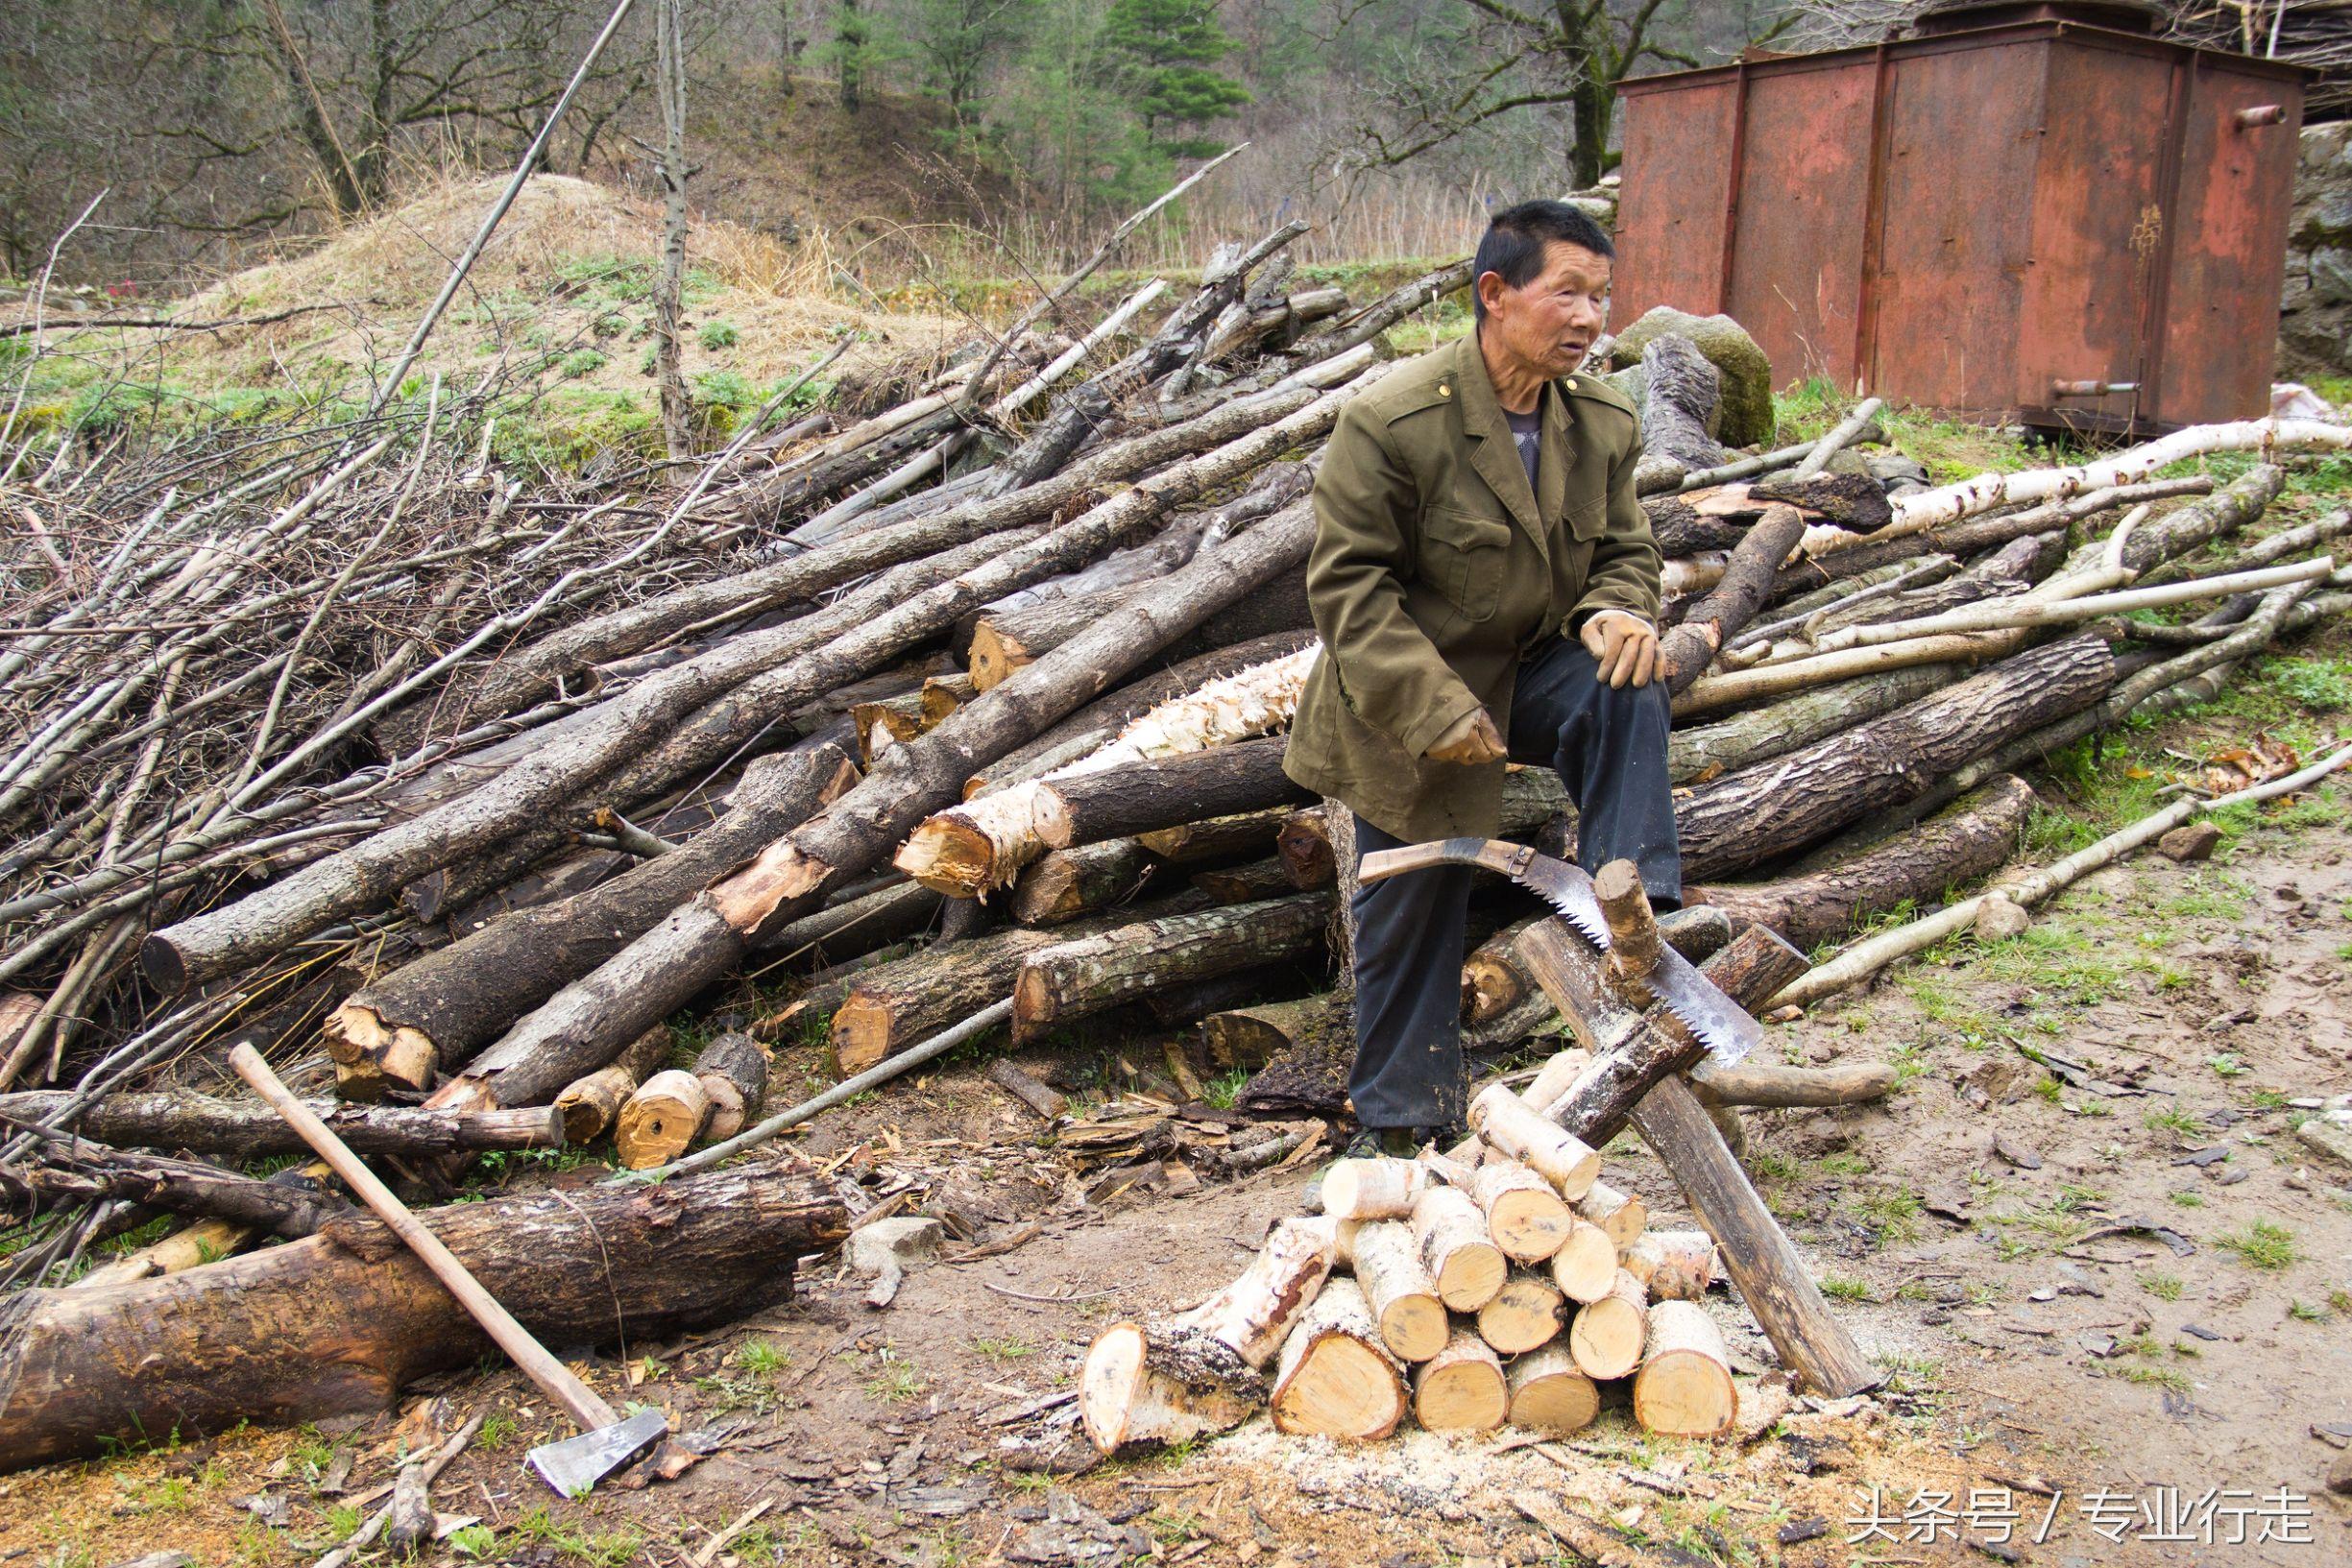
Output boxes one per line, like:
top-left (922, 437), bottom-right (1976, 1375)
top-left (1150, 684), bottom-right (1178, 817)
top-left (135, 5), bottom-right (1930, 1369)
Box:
top-left (1284, 336), bottom-right (1659, 844)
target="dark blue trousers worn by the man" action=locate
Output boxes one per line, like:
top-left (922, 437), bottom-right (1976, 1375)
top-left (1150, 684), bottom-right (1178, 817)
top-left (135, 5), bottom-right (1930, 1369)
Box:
top-left (1347, 637), bottom-right (1682, 1142)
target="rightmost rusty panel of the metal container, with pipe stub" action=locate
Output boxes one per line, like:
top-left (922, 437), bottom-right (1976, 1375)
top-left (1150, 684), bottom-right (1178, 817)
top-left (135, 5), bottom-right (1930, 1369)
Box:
top-left (2147, 54), bottom-right (2303, 425)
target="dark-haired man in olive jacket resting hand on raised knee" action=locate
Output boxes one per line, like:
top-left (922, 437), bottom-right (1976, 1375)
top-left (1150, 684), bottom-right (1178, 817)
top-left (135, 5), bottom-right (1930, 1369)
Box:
top-left (1284, 203), bottom-right (1682, 1154)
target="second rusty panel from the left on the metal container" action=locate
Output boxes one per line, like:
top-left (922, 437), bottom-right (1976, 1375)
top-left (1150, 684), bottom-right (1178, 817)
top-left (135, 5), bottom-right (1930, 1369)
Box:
top-left (1724, 57), bottom-right (1877, 386)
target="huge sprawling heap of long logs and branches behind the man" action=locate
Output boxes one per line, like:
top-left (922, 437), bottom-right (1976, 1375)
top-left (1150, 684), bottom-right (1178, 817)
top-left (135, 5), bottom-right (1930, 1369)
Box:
top-left (0, 200), bottom-right (2352, 1462)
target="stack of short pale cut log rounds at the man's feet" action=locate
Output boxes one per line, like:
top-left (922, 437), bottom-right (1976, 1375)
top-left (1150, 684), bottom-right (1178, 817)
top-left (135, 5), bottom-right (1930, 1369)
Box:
top-left (1078, 1049), bottom-right (1738, 1453)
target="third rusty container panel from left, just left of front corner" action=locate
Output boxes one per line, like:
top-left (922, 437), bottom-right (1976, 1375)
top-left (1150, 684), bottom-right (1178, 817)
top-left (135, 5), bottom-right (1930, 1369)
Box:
top-left (1862, 40), bottom-right (2049, 411)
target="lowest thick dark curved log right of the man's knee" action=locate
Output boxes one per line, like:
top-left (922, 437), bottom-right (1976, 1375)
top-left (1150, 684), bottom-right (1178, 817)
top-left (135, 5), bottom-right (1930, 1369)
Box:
top-left (1682, 773), bottom-right (2037, 948)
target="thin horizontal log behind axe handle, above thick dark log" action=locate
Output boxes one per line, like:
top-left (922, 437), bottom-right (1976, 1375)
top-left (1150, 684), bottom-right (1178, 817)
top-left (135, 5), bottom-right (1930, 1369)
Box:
top-left (0, 1089), bottom-right (565, 1161)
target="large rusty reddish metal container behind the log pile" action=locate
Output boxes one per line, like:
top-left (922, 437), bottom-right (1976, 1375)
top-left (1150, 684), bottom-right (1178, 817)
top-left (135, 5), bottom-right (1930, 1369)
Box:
top-left (1615, 2), bottom-right (2305, 435)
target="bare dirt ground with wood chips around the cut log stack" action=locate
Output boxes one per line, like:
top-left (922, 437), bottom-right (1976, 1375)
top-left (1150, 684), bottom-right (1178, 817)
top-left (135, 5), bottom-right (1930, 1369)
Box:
top-left (0, 808), bottom-right (2352, 1568)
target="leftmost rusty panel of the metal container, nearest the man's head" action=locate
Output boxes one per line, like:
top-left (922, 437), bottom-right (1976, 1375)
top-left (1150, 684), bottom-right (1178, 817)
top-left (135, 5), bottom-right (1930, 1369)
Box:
top-left (1612, 70), bottom-right (1740, 322)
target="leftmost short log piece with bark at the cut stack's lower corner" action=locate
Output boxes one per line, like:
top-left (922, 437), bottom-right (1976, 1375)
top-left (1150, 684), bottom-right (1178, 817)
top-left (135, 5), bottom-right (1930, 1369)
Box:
top-left (1078, 1323), bottom-right (1266, 1455)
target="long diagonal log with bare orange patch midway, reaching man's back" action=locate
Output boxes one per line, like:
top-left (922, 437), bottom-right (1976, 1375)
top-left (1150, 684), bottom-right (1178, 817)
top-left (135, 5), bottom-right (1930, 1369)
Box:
top-left (435, 446), bottom-right (1336, 1123)
